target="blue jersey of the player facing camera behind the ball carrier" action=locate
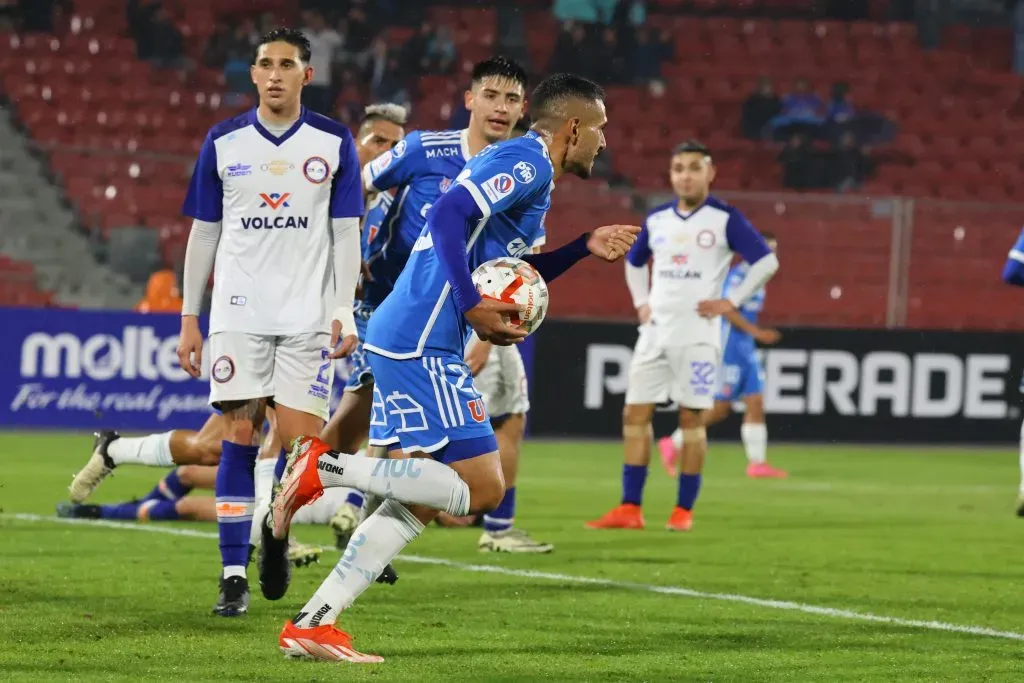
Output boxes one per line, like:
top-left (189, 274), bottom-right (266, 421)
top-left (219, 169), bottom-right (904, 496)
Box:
top-left (362, 130), bottom-right (469, 306)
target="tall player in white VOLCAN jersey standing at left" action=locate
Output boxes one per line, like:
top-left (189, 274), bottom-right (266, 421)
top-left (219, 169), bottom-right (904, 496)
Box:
top-left (178, 29), bottom-right (364, 616)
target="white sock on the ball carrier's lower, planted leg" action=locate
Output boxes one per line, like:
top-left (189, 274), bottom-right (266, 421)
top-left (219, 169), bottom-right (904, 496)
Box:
top-left (292, 500), bottom-right (423, 629)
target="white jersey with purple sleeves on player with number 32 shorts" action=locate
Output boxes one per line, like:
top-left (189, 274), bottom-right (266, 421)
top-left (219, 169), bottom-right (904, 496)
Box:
top-left (627, 197), bottom-right (768, 347)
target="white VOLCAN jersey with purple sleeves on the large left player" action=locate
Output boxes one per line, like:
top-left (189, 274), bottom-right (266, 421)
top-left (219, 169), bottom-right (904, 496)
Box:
top-left (183, 108), bottom-right (364, 335)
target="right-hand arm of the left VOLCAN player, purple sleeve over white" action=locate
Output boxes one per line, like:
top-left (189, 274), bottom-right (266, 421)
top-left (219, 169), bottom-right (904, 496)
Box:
top-left (331, 130), bottom-right (365, 358)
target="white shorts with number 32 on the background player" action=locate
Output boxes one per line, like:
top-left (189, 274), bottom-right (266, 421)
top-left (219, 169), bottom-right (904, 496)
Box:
top-left (626, 325), bottom-right (720, 411)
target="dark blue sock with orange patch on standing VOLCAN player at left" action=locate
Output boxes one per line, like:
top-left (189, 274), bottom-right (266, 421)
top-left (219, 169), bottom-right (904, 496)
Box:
top-left (213, 441), bottom-right (259, 567)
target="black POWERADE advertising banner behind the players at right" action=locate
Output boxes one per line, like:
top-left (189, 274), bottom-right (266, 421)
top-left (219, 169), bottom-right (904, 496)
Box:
top-left (530, 321), bottom-right (1024, 443)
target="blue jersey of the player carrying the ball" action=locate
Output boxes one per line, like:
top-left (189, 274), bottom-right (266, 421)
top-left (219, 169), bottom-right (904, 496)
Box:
top-left (366, 132), bottom-right (554, 359)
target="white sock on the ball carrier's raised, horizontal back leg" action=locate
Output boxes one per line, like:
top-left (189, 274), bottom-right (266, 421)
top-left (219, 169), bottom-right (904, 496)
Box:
top-left (316, 451), bottom-right (469, 517)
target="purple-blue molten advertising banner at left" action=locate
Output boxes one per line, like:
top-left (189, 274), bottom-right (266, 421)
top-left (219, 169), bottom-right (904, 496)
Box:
top-left (0, 308), bottom-right (210, 431)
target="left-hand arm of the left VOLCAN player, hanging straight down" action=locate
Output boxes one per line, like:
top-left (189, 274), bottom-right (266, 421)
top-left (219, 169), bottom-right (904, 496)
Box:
top-left (178, 135), bottom-right (224, 377)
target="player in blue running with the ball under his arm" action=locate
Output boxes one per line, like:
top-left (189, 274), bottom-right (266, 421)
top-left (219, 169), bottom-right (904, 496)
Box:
top-left (272, 74), bottom-right (640, 663)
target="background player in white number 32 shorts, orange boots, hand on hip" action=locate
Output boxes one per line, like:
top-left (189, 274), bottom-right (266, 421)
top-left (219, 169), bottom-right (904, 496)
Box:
top-left (587, 140), bottom-right (778, 531)
